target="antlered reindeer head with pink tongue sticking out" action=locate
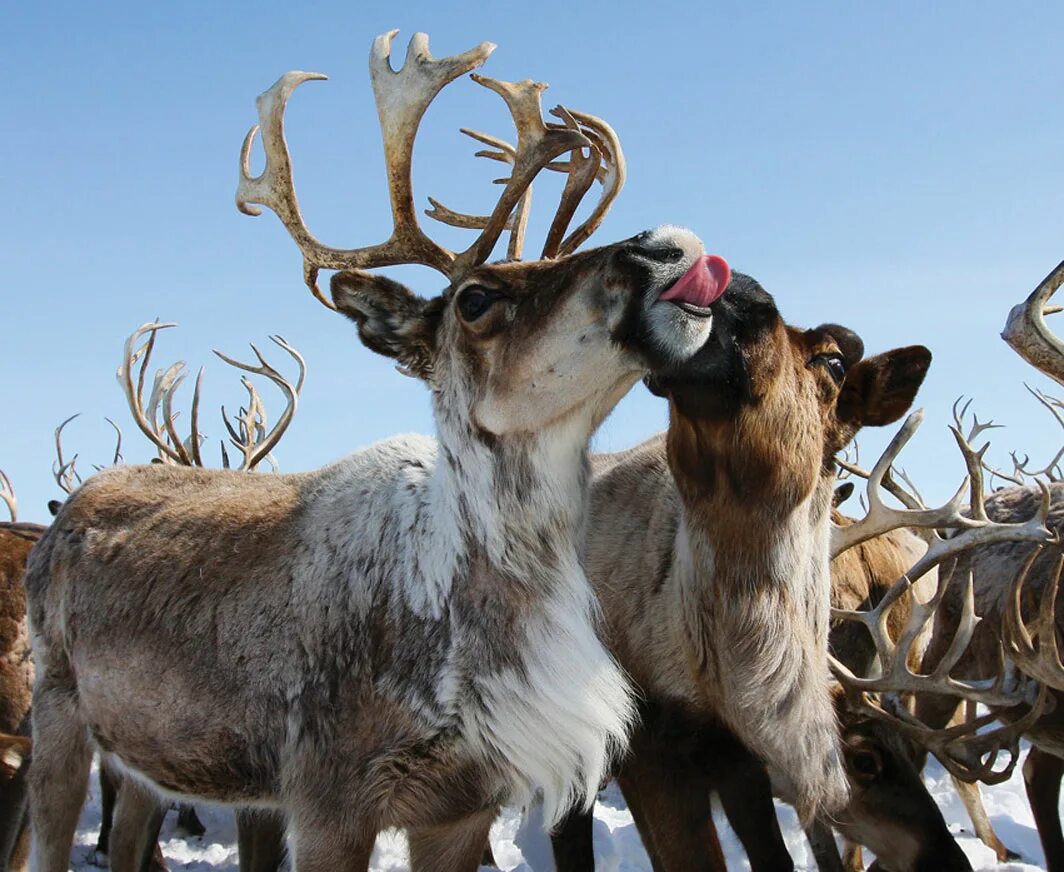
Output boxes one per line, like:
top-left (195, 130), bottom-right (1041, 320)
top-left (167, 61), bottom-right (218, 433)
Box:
top-left (237, 32), bottom-right (727, 437)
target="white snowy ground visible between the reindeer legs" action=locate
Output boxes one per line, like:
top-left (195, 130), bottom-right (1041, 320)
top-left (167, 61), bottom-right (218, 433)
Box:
top-left (71, 748), bottom-right (1045, 872)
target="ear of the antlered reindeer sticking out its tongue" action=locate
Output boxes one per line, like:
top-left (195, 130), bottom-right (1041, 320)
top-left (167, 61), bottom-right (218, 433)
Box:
top-left (330, 270), bottom-right (443, 381)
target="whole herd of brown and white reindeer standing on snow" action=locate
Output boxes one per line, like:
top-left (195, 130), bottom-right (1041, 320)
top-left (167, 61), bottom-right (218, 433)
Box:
top-left (0, 32), bottom-right (1064, 872)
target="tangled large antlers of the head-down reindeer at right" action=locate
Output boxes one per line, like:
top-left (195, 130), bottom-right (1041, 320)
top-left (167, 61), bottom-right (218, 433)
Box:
top-left (832, 401), bottom-right (1055, 783)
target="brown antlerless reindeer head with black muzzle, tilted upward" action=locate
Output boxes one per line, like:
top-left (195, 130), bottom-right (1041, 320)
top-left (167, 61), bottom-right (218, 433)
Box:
top-left (648, 273), bottom-right (931, 512)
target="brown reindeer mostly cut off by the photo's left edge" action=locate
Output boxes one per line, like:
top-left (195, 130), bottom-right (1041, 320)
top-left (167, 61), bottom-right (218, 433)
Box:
top-left (0, 471), bottom-right (45, 870)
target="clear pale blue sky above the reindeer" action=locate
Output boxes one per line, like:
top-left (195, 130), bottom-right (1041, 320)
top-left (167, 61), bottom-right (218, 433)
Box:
top-left (0, 0), bottom-right (1064, 520)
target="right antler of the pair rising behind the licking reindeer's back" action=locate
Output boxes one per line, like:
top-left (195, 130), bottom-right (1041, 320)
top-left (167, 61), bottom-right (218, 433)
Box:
top-left (215, 336), bottom-right (306, 470)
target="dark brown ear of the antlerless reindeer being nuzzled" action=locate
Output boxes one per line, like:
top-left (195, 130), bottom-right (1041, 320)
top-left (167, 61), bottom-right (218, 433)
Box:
top-left (835, 346), bottom-right (931, 432)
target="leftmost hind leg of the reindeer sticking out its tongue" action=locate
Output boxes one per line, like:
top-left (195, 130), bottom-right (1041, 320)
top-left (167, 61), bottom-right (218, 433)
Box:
top-left (30, 680), bottom-right (93, 872)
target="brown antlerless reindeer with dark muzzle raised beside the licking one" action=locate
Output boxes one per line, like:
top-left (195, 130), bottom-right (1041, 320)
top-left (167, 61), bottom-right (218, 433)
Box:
top-left (523, 266), bottom-right (931, 870)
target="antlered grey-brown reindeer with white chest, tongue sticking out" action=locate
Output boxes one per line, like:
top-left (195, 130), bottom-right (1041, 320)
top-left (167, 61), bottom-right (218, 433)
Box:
top-left (27, 32), bottom-right (740, 872)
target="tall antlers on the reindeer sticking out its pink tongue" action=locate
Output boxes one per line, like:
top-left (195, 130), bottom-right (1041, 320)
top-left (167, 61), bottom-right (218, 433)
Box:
top-left (236, 31), bottom-right (625, 308)
